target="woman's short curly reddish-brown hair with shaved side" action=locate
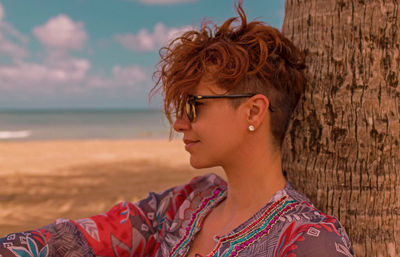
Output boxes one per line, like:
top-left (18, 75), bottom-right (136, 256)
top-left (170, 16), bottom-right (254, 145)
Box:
top-left (151, 0), bottom-right (306, 146)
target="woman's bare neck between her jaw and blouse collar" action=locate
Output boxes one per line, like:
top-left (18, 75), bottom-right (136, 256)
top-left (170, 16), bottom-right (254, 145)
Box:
top-left (219, 139), bottom-right (286, 216)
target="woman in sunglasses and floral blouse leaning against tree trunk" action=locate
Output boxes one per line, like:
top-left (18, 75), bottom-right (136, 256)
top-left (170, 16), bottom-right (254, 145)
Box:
top-left (0, 2), bottom-right (353, 257)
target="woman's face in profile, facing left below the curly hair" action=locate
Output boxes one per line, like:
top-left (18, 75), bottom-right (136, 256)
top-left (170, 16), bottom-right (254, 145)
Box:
top-left (173, 81), bottom-right (248, 168)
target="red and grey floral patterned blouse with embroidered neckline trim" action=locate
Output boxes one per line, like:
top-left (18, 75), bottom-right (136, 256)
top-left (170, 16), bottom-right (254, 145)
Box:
top-left (0, 174), bottom-right (353, 257)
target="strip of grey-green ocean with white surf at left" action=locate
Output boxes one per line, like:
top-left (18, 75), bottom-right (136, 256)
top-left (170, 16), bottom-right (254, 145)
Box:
top-left (0, 110), bottom-right (169, 142)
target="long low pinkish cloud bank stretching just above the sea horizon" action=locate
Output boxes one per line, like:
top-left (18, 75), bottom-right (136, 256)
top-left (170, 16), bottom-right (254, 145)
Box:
top-left (0, 58), bottom-right (153, 100)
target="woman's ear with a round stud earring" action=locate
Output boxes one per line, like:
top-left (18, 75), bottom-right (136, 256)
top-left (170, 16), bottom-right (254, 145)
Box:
top-left (247, 94), bottom-right (269, 129)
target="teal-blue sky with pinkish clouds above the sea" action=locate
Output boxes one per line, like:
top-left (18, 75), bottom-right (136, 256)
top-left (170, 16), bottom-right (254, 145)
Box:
top-left (0, 0), bottom-right (284, 110)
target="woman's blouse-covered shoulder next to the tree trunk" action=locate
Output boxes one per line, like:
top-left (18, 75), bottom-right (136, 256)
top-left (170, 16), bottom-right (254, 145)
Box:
top-left (276, 185), bottom-right (354, 257)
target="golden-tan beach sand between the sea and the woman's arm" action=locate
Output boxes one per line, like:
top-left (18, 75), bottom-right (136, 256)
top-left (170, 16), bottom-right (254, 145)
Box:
top-left (0, 140), bottom-right (223, 237)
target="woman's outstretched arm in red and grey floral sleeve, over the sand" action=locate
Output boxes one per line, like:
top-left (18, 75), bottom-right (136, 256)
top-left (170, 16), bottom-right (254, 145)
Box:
top-left (0, 186), bottom-right (180, 257)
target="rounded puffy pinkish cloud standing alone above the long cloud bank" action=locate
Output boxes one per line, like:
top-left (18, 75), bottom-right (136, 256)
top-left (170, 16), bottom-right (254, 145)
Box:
top-left (33, 14), bottom-right (88, 50)
